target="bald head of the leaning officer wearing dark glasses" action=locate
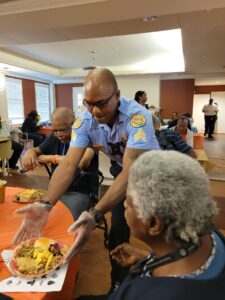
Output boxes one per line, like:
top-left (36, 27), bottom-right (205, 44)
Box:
top-left (84, 68), bottom-right (120, 126)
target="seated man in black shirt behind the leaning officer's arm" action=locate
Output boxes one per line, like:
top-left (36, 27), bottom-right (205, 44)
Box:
top-left (22, 107), bottom-right (98, 219)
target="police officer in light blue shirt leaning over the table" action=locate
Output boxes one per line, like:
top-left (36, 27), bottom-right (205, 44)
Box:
top-left (14, 69), bottom-right (159, 285)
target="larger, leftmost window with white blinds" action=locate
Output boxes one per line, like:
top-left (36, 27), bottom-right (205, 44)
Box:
top-left (6, 77), bottom-right (24, 124)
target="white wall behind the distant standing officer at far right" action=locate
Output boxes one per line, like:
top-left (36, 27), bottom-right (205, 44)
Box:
top-left (193, 92), bottom-right (225, 133)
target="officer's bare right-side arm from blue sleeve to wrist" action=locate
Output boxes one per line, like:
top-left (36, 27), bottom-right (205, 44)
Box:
top-left (96, 148), bottom-right (145, 213)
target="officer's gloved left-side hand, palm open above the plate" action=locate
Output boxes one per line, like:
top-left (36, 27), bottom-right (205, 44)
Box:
top-left (13, 203), bottom-right (50, 245)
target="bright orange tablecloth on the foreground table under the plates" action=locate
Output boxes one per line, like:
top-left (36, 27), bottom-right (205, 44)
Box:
top-left (0, 187), bottom-right (79, 300)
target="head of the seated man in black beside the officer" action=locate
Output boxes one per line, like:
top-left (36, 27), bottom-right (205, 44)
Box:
top-left (51, 107), bottom-right (75, 143)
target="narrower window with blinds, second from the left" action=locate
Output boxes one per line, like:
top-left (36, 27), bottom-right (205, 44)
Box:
top-left (35, 82), bottom-right (50, 121)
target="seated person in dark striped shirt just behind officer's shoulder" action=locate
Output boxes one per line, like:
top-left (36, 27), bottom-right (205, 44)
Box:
top-left (152, 115), bottom-right (196, 158)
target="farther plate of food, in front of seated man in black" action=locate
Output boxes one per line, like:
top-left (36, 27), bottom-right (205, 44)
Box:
top-left (13, 189), bottom-right (45, 203)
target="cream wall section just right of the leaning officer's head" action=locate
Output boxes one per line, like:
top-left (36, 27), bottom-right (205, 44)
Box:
top-left (116, 75), bottom-right (160, 107)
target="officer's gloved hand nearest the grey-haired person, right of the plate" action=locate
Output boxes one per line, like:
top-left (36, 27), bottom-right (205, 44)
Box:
top-left (64, 211), bottom-right (97, 262)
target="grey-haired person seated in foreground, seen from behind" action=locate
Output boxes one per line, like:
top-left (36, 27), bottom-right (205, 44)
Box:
top-left (108, 151), bottom-right (225, 300)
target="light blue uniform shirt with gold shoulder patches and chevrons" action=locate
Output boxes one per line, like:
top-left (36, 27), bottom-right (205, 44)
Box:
top-left (70, 97), bottom-right (160, 164)
